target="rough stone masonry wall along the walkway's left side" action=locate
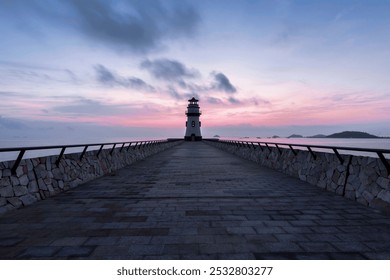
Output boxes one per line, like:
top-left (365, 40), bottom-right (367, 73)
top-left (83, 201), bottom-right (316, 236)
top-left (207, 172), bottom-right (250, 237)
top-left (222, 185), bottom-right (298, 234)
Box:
top-left (0, 141), bottom-right (181, 215)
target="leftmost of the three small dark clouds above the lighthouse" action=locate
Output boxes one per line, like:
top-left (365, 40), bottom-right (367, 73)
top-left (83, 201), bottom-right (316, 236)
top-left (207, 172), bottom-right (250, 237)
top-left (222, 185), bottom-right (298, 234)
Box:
top-left (94, 64), bottom-right (155, 92)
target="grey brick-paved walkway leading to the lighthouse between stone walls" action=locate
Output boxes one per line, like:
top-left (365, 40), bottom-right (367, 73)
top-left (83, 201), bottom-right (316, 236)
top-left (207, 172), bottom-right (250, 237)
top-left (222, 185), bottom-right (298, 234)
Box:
top-left (0, 142), bottom-right (390, 259)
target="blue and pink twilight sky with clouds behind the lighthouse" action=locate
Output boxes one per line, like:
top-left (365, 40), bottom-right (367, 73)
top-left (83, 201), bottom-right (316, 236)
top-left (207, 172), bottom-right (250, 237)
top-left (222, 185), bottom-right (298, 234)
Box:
top-left (0, 0), bottom-right (390, 142)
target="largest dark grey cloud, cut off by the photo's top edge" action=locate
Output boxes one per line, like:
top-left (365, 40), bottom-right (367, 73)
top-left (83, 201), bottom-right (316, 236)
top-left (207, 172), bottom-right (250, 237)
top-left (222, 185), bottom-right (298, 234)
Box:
top-left (70, 0), bottom-right (200, 53)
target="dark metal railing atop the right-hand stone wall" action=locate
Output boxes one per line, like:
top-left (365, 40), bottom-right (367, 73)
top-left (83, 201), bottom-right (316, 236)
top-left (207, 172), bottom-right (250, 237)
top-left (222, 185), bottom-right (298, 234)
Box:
top-left (204, 140), bottom-right (390, 174)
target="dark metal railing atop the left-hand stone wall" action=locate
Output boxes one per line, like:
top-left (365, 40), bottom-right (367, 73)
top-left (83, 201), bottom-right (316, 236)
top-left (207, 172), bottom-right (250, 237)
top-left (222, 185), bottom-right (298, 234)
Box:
top-left (0, 139), bottom-right (179, 175)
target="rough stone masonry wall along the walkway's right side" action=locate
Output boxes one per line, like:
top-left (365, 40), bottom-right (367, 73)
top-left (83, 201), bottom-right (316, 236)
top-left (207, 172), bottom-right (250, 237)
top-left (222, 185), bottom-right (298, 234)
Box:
top-left (207, 141), bottom-right (390, 211)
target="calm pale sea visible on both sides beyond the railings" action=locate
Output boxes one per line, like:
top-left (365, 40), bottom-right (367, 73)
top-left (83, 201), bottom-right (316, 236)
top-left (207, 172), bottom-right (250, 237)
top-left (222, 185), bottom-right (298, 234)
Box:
top-left (0, 137), bottom-right (390, 162)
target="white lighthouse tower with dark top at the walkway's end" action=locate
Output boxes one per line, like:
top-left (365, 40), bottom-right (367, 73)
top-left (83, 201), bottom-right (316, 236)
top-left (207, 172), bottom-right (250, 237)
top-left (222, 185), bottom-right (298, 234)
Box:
top-left (184, 97), bottom-right (202, 141)
